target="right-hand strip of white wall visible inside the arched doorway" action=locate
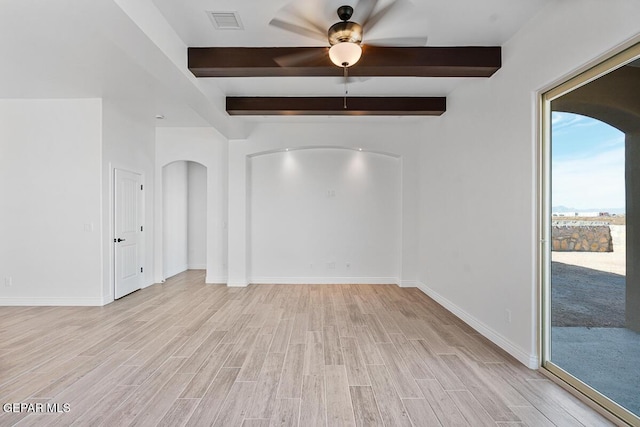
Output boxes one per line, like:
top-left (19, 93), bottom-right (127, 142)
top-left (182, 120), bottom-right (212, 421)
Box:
top-left (187, 162), bottom-right (207, 270)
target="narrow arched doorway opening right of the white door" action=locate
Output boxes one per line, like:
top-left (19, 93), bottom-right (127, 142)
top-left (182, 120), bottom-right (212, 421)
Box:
top-left (162, 160), bottom-right (207, 279)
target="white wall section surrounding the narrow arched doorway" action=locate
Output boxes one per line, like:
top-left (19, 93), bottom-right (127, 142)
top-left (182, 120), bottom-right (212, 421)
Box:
top-left (154, 127), bottom-right (228, 283)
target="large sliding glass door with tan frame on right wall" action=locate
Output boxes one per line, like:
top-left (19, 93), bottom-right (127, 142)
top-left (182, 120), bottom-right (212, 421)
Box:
top-left (541, 42), bottom-right (640, 423)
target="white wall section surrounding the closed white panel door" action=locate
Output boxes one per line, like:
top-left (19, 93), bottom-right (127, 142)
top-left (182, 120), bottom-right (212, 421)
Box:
top-left (102, 99), bottom-right (162, 302)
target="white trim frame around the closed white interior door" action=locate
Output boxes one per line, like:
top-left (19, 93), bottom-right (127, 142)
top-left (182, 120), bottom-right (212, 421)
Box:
top-left (110, 166), bottom-right (149, 302)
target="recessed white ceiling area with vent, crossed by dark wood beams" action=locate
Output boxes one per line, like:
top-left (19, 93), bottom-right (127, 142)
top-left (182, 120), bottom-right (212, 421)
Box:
top-left (152, 0), bottom-right (548, 100)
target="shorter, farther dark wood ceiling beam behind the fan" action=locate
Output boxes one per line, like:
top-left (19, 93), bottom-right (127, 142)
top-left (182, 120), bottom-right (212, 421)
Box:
top-left (227, 97), bottom-right (447, 116)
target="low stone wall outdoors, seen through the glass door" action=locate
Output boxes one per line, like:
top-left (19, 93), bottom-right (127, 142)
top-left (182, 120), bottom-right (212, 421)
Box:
top-left (551, 221), bottom-right (613, 252)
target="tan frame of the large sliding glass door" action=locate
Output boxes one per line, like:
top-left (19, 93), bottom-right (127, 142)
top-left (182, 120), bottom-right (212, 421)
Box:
top-left (537, 40), bottom-right (640, 425)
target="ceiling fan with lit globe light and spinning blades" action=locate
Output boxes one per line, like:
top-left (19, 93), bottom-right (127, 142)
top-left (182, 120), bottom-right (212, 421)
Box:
top-left (269, 0), bottom-right (427, 71)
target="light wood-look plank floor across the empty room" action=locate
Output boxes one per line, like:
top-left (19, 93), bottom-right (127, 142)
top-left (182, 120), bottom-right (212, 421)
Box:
top-left (0, 271), bottom-right (610, 427)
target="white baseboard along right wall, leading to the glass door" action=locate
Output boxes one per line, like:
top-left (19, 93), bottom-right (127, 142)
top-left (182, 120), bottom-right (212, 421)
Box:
top-left (416, 283), bottom-right (540, 369)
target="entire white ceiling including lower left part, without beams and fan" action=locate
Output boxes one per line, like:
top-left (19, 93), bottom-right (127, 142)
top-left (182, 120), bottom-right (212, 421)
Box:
top-left (0, 0), bottom-right (554, 136)
